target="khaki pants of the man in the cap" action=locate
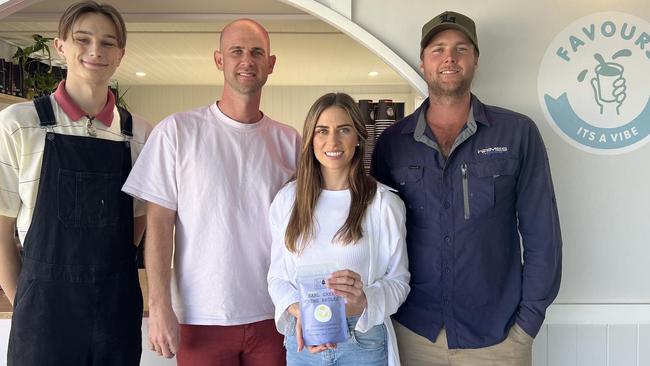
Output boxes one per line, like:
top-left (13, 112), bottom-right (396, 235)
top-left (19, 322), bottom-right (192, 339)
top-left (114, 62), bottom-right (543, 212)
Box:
top-left (393, 321), bottom-right (533, 366)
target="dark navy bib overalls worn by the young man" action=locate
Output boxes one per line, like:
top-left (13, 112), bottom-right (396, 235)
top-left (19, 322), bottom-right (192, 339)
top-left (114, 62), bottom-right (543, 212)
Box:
top-left (8, 96), bottom-right (142, 366)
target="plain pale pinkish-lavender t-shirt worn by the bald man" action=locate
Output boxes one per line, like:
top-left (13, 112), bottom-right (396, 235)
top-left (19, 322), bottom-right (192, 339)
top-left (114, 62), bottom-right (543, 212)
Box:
top-left (123, 103), bottom-right (300, 325)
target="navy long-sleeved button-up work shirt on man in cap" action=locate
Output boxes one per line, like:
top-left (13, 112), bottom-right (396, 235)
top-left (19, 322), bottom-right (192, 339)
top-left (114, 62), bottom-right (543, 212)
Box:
top-left (371, 95), bottom-right (562, 348)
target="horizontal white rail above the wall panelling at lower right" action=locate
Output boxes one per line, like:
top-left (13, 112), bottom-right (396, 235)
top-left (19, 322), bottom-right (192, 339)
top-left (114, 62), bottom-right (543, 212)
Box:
top-left (545, 304), bottom-right (650, 324)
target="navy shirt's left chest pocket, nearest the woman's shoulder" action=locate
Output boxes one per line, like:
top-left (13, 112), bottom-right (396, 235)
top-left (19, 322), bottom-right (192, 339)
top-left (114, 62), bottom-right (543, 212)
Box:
top-left (391, 165), bottom-right (427, 227)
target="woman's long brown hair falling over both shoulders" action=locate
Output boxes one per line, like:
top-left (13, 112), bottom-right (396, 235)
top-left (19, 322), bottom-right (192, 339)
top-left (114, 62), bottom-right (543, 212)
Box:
top-left (284, 93), bottom-right (377, 253)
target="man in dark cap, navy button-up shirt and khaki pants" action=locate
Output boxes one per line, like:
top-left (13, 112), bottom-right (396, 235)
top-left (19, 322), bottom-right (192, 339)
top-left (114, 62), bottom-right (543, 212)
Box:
top-left (372, 12), bottom-right (562, 366)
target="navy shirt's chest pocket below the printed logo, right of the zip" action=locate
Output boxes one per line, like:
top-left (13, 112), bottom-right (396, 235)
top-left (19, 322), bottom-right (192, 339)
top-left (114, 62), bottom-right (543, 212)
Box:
top-left (460, 159), bottom-right (519, 220)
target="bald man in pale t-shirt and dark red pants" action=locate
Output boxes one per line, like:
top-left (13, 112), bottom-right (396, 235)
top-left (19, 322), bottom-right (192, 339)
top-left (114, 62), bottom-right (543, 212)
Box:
top-left (123, 19), bottom-right (300, 366)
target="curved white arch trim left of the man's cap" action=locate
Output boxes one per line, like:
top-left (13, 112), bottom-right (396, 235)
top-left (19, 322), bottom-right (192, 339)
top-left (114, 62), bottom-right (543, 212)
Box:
top-left (278, 0), bottom-right (428, 96)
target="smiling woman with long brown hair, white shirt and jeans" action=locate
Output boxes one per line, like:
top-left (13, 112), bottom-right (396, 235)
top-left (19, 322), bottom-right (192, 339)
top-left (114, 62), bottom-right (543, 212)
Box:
top-left (268, 93), bottom-right (410, 366)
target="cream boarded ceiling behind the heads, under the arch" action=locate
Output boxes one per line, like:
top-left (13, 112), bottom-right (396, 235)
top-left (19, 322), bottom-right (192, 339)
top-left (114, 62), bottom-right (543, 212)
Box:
top-left (0, 0), bottom-right (407, 85)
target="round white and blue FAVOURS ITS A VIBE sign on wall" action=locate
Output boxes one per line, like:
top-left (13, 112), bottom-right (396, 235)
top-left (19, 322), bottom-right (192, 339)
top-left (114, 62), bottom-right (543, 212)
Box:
top-left (538, 12), bottom-right (650, 154)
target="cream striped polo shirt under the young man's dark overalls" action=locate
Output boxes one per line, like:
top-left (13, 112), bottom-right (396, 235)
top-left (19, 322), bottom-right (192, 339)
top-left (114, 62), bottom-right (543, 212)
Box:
top-left (0, 95), bottom-right (151, 242)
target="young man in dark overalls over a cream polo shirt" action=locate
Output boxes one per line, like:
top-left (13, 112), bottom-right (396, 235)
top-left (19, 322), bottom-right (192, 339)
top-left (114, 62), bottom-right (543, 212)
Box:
top-left (0, 2), bottom-right (148, 366)
